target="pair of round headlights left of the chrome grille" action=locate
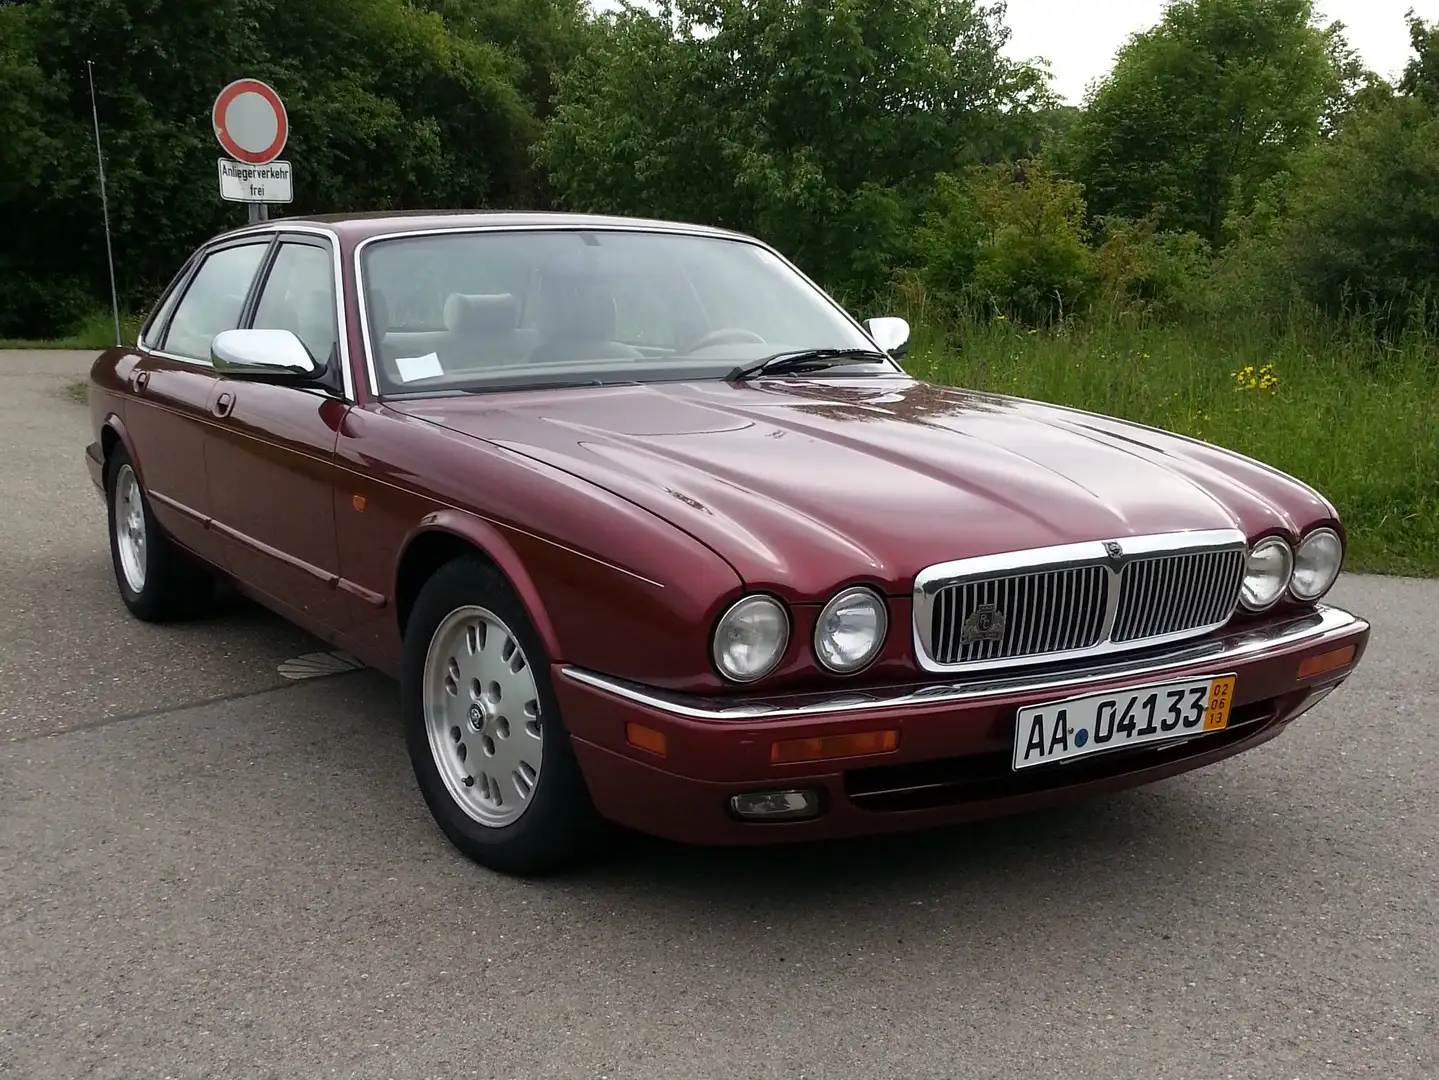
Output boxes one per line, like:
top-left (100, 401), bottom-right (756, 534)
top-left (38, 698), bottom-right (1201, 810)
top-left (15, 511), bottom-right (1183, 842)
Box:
top-left (712, 587), bottom-right (889, 683)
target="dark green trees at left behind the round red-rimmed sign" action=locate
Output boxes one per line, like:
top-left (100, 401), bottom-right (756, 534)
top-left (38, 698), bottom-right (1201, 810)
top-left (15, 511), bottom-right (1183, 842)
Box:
top-left (0, 0), bottom-right (566, 335)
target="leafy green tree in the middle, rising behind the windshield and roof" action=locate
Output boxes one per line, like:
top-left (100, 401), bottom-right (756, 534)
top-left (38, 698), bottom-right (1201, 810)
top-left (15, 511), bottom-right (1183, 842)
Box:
top-left (540, 0), bottom-right (1050, 295)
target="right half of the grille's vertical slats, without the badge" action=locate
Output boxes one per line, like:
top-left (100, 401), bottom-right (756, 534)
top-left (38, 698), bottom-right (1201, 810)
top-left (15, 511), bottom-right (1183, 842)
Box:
top-left (1109, 551), bottom-right (1245, 643)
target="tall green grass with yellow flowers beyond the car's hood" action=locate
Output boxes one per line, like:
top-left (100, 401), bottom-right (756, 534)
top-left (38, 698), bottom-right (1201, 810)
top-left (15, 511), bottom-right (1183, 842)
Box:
top-left (907, 307), bottom-right (1439, 574)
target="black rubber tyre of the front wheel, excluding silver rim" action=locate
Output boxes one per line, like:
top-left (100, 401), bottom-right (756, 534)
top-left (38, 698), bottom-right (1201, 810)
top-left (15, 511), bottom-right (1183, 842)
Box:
top-left (400, 557), bottom-right (607, 876)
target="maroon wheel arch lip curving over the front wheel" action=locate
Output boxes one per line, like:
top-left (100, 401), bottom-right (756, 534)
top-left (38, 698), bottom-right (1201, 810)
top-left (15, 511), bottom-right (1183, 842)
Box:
top-left (393, 509), bottom-right (561, 660)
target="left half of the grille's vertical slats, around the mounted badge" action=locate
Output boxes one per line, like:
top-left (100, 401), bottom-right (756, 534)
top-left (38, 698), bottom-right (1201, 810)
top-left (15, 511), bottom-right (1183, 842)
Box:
top-left (932, 567), bottom-right (1109, 664)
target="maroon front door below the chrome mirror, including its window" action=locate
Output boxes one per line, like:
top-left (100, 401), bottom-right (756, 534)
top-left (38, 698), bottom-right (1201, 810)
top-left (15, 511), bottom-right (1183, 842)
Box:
top-left (206, 233), bottom-right (351, 630)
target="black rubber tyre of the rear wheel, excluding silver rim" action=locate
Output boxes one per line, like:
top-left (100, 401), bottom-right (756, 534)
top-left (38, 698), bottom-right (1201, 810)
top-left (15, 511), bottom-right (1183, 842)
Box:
top-left (105, 446), bottom-right (214, 623)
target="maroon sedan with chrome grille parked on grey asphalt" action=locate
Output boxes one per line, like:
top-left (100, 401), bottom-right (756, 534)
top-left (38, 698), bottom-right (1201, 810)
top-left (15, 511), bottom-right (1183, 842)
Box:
top-left (88, 214), bottom-right (1368, 873)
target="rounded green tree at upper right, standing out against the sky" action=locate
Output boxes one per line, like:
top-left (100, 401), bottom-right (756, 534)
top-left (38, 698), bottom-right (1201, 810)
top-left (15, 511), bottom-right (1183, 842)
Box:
top-left (1069, 0), bottom-right (1360, 243)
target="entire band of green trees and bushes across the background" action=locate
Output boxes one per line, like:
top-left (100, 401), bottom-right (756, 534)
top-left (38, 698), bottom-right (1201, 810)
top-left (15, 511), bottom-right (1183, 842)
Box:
top-left (0, 0), bottom-right (1439, 359)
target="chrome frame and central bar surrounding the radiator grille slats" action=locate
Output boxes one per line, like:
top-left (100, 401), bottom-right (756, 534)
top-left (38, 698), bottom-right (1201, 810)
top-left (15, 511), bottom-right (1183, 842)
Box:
top-left (911, 529), bottom-right (1248, 674)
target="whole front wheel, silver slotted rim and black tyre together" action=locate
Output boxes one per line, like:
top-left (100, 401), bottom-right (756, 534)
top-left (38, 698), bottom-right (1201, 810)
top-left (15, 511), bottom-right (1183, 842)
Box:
top-left (400, 558), bottom-right (597, 873)
